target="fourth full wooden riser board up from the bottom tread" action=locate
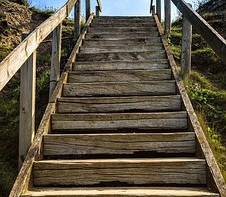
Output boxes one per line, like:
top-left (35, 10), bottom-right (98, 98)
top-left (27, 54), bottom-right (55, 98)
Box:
top-left (57, 95), bottom-right (182, 113)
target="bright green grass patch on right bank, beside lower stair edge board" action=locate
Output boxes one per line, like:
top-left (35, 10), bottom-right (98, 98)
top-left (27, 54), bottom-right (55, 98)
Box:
top-left (184, 71), bottom-right (226, 180)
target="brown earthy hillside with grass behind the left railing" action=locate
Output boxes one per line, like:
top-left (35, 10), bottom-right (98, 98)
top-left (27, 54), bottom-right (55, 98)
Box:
top-left (0, 0), bottom-right (73, 197)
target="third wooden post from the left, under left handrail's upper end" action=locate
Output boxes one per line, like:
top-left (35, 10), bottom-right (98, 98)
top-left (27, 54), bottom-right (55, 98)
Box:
top-left (74, 0), bottom-right (81, 41)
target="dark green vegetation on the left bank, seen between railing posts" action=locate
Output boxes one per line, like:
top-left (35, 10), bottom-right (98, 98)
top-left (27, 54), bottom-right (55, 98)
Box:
top-left (0, 1), bottom-right (74, 197)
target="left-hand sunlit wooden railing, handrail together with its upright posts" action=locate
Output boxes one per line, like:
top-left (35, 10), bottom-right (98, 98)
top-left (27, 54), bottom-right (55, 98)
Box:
top-left (0, 0), bottom-right (102, 169)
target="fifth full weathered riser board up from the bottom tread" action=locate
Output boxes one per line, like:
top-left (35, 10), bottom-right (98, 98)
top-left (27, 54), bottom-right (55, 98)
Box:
top-left (63, 80), bottom-right (176, 97)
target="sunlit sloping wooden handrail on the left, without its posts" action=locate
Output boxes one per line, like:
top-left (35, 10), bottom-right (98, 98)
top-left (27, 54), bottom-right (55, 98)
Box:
top-left (0, 0), bottom-right (78, 91)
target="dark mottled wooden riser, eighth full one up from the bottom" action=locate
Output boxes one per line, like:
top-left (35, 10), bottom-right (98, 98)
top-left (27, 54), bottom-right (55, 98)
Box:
top-left (77, 50), bottom-right (166, 62)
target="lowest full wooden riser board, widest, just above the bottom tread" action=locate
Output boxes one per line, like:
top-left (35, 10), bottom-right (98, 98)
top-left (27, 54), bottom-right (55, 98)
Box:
top-left (33, 158), bottom-right (206, 186)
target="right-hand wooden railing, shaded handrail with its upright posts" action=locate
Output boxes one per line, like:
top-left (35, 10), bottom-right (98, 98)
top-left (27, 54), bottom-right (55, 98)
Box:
top-left (151, 0), bottom-right (226, 76)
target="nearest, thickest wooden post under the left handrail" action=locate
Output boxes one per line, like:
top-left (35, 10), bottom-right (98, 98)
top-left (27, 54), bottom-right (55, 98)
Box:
top-left (19, 34), bottom-right (36, 170)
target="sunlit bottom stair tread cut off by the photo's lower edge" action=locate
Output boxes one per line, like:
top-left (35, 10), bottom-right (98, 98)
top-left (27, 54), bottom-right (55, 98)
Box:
top-left (22, 187), bottom-right (220, 197)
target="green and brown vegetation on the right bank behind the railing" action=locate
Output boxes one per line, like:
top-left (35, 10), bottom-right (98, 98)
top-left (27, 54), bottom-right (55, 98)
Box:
top-left (169, 0), bottom-right (226, 179)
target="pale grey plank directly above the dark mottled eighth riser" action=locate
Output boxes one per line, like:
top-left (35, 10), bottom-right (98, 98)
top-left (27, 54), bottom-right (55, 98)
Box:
top-left (80, 43), bottom-right (163, 54)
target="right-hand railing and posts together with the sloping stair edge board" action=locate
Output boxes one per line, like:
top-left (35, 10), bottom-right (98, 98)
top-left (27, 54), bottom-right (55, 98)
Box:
top-left (151, 0), bottom-right (226, 197)
